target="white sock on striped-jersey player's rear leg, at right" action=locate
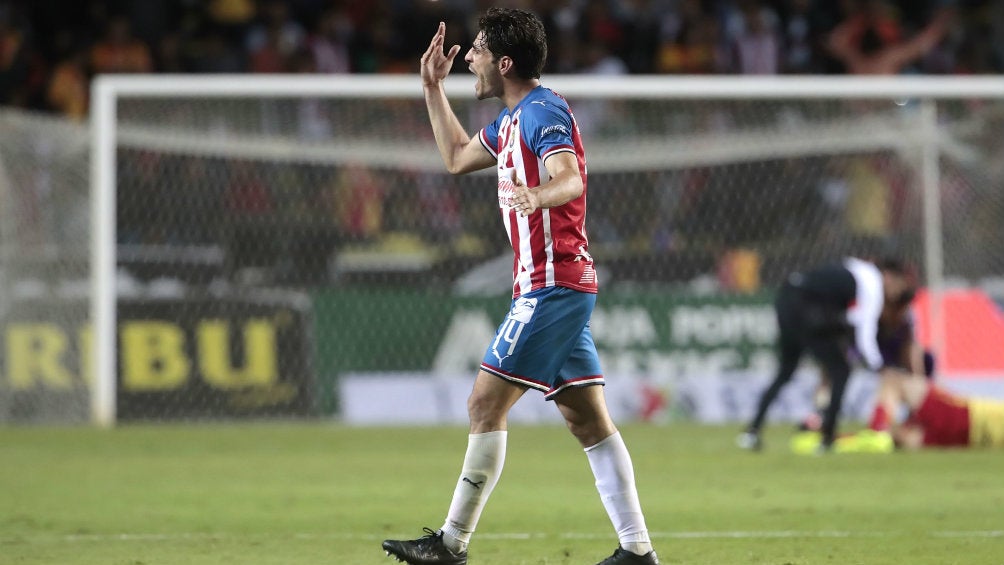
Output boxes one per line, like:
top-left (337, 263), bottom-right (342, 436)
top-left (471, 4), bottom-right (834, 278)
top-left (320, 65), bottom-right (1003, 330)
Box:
top-left (585, 432), bottom-right (652, 555)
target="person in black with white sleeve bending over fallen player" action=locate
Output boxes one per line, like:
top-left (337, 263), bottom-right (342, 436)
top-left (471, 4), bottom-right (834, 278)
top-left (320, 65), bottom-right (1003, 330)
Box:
top-left (737, 257), bottom-right (910, 451)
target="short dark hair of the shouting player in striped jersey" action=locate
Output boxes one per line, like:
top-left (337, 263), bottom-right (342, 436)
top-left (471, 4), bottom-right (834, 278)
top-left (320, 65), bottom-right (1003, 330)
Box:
top-left (478, 7), bottom-right (547, 79)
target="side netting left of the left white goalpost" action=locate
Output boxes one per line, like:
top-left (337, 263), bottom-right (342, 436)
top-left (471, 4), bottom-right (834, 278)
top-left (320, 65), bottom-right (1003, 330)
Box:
top-left (0, 109), bottom-right (91, 422)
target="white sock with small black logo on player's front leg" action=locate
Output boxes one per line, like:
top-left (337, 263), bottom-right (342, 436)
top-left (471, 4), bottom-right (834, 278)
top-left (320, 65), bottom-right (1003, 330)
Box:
top-left (443, 432), bottom-right (508, 552)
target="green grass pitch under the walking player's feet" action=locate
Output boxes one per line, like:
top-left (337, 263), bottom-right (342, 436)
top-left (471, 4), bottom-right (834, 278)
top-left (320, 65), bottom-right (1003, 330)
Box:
top-left (0, 423), bottom-right (1004, 565)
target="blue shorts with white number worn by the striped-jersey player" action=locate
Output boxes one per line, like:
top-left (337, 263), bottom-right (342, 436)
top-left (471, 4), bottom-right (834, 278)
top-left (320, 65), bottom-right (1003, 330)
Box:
top-left (481, 286), bottom-right (604, 400)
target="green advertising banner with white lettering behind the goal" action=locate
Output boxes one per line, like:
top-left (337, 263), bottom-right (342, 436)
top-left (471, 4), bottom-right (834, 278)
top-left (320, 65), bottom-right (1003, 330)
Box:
top-left (314, 290), bottom-right (777, 413)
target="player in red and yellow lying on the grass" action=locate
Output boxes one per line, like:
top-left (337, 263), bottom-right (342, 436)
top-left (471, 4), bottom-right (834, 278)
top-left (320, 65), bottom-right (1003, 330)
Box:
top-left (879, 371), bottom-right (1004, 450)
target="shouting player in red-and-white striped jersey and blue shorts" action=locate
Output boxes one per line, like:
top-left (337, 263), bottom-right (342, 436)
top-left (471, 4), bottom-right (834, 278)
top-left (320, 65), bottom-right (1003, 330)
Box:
top-left (383, 8), bottom-right (659, 565)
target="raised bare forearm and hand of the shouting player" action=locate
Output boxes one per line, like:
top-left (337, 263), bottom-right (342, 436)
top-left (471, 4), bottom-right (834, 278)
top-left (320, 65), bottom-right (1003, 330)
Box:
top-left (422, 22), bottom-right (495, 175)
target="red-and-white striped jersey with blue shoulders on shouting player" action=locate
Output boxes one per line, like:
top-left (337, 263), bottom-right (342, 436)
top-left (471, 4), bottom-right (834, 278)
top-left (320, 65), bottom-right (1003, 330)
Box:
top-left (479, 86), bottom-right (596, 298)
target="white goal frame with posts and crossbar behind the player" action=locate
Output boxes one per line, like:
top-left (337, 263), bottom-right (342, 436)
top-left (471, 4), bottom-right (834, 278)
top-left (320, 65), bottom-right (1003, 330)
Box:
top-left (90, 74), bottom-right (1004, 427)
